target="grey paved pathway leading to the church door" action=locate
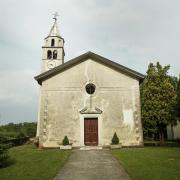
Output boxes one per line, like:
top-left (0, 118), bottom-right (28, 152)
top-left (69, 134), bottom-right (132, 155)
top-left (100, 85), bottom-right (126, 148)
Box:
top-left (54, 150), bottom-right (130, 180)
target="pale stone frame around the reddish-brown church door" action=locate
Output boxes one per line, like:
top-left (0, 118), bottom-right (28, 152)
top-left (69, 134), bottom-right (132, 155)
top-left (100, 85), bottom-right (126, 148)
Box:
top-left (80, 114), bottom-right (103, 146)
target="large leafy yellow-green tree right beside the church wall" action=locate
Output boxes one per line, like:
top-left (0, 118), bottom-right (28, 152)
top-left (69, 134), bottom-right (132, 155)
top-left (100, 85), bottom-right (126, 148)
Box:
top-left (141, 62), bottom-right (176, 145)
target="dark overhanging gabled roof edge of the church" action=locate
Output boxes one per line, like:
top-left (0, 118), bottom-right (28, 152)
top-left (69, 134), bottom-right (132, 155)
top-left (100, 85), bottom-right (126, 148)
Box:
top-left (35, 52), bottom-right (145, 85)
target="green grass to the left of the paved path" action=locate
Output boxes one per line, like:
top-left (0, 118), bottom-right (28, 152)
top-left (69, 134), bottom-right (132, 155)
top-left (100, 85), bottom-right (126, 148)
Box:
top-left (0, 145), bottom-right (71, 180)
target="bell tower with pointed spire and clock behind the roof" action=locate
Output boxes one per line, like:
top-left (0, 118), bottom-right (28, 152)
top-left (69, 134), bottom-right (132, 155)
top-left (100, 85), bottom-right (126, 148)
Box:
top-left (41, 13), bottom-right (65, 73)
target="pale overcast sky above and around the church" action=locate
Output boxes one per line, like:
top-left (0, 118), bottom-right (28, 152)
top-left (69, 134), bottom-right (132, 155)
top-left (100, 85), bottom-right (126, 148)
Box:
top-left (0, 0), bottom-right (180, 124)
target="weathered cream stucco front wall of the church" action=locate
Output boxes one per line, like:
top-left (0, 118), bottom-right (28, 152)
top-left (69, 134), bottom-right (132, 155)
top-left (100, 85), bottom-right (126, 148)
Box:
top-left (38, 59), bottom-right (143, 147)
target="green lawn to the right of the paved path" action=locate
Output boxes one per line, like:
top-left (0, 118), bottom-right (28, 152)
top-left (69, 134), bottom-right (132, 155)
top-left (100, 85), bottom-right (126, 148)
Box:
top-left (112, 147), bottom-right (180, 180)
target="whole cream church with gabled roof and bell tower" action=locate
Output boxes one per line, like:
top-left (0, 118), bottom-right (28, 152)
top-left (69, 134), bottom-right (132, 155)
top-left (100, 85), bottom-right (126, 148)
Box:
top-left (35, 17), bottom-right (144, 148)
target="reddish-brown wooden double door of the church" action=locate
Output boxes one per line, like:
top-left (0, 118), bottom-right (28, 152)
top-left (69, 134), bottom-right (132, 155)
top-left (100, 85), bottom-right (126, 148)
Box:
top-left (84, 118), bottom-right (98, 146)
